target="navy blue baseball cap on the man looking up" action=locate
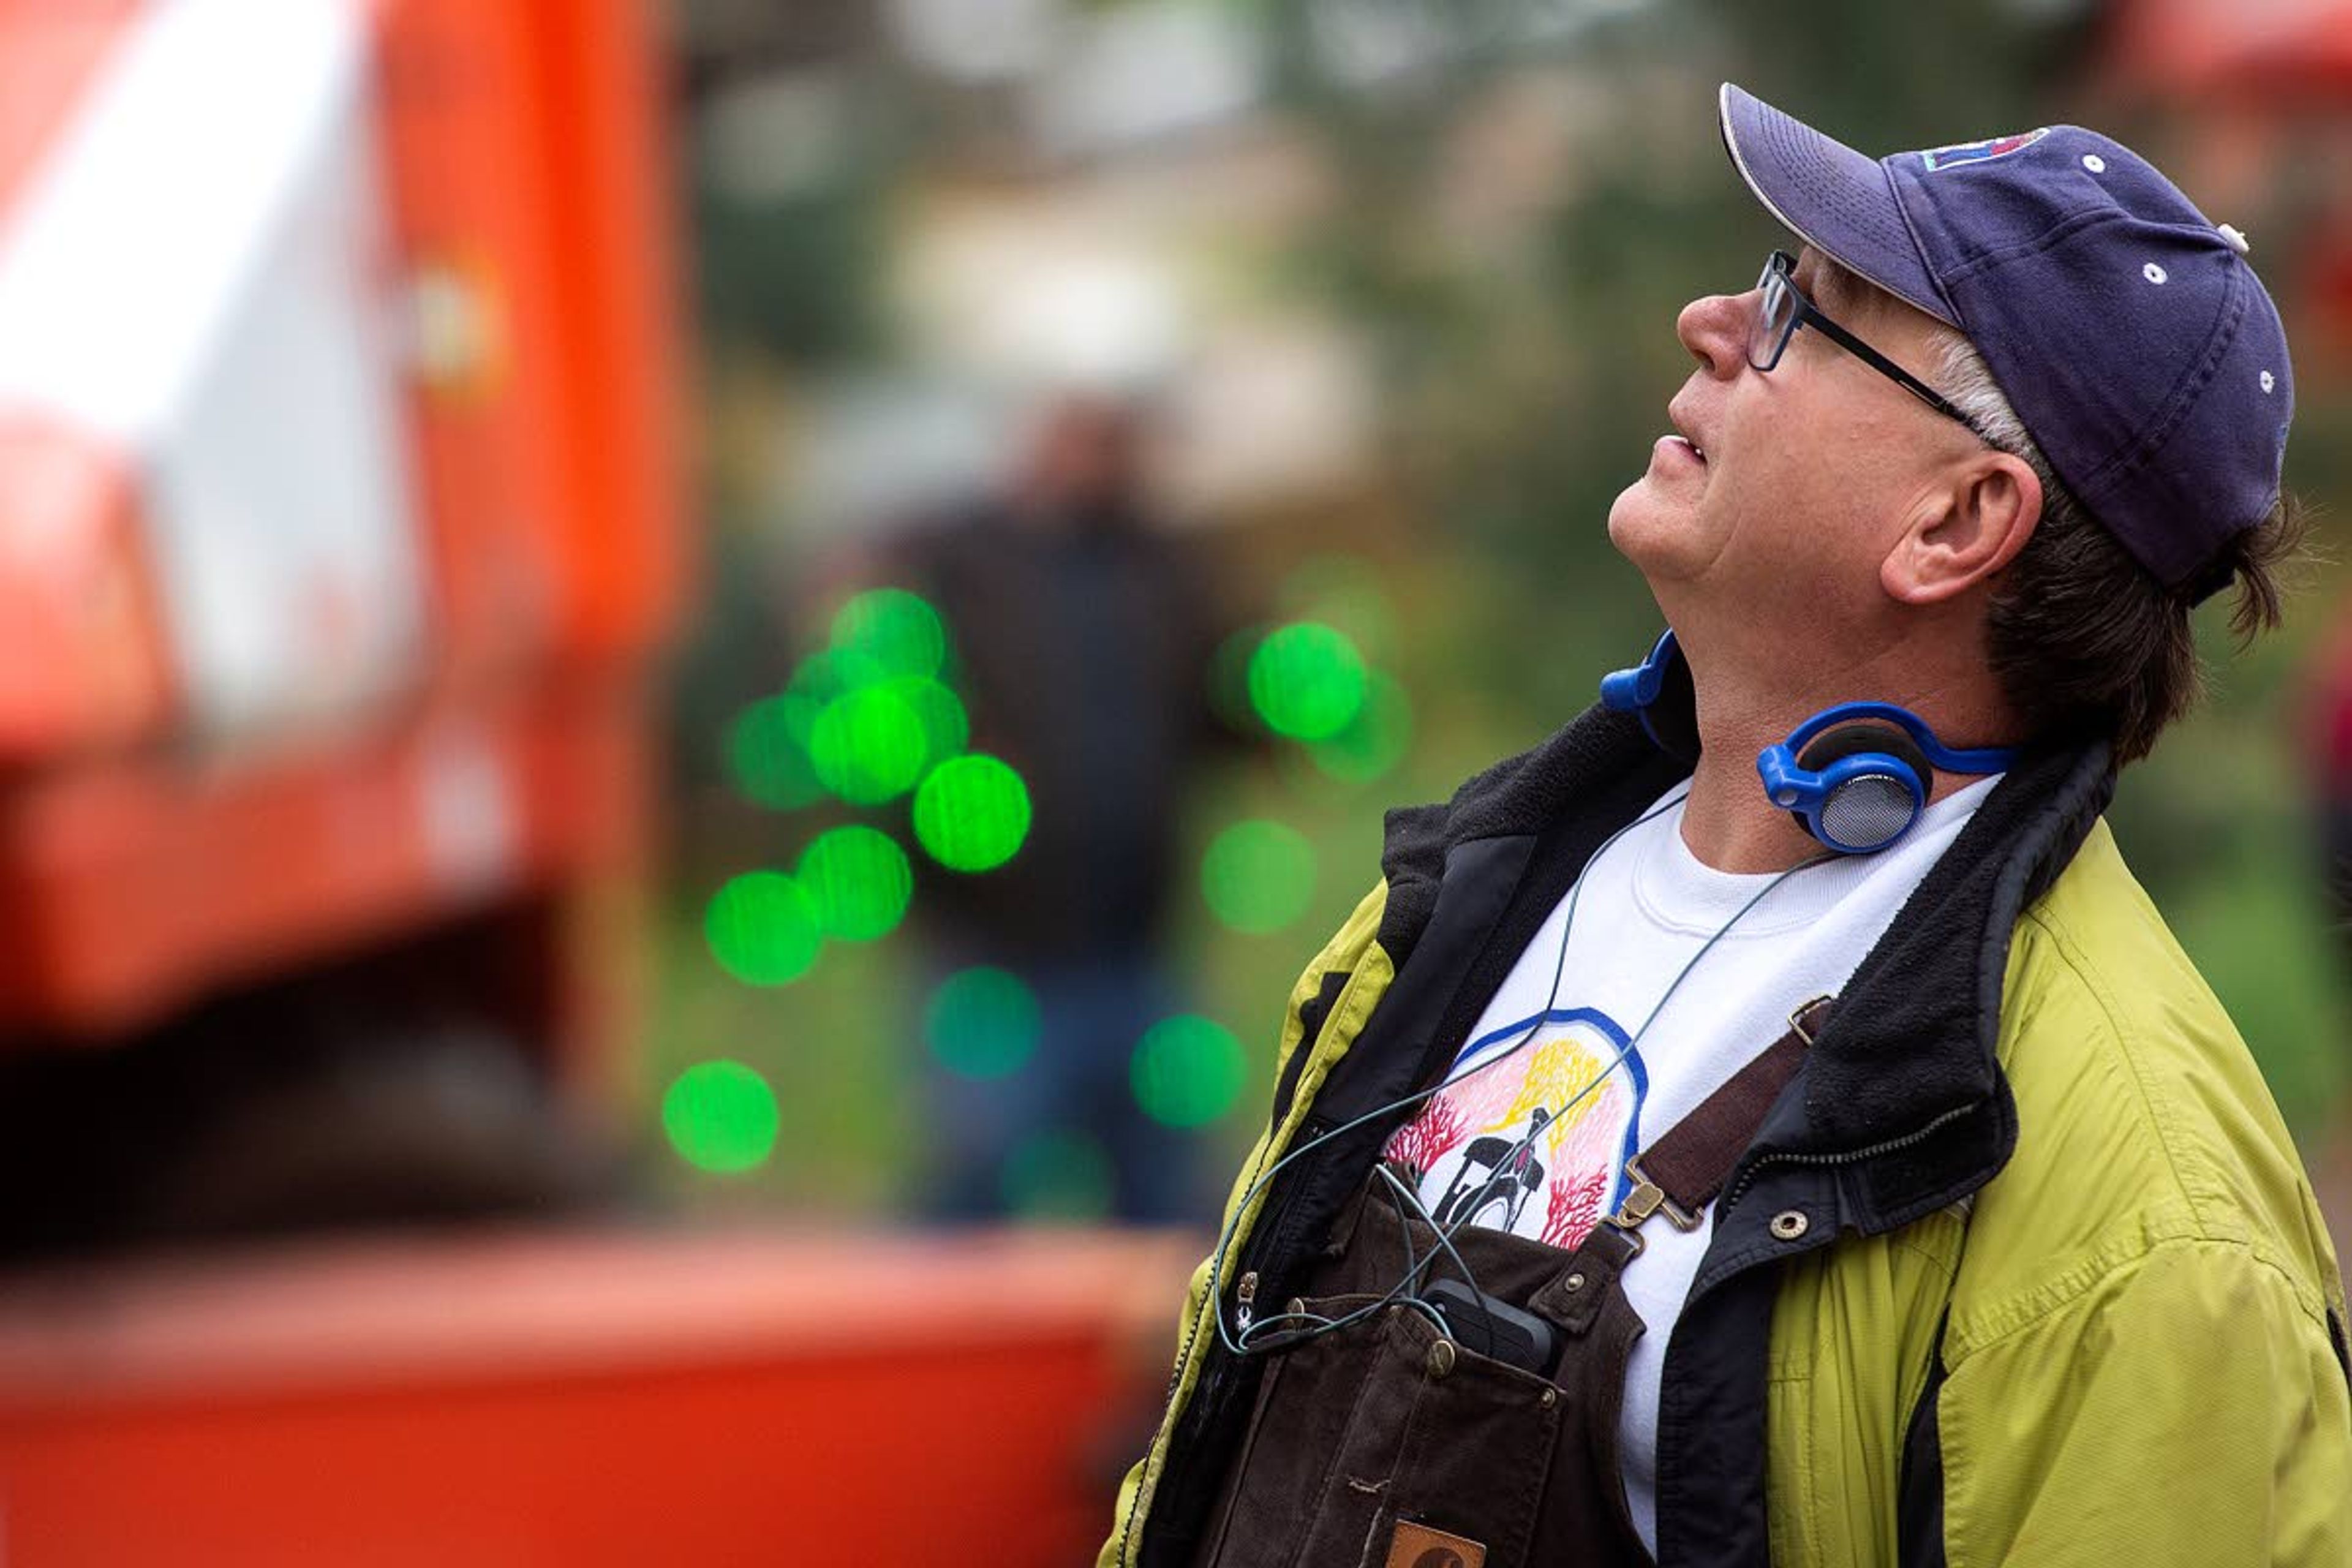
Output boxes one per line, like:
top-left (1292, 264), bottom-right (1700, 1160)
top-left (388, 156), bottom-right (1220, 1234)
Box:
top-left (1722, 82), bottom-right (2296, 597)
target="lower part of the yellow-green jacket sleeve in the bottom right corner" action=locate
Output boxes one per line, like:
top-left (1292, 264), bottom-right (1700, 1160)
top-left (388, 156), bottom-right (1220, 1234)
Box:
top-left (1936, 1239), bottom-right (2352, 1568)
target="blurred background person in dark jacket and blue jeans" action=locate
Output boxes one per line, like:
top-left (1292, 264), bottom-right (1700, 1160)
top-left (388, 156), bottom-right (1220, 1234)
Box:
top-left (894, 390), bottom-right (1221, 1225)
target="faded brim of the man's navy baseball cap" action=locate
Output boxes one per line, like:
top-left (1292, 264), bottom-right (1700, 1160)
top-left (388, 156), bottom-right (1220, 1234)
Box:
top-left (1722, 82), bottom-right (1962, 326)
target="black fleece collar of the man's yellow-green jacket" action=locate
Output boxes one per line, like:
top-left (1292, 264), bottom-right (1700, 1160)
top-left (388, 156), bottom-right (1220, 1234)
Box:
top-left (1381, 705), bottom-right (2114, 1229)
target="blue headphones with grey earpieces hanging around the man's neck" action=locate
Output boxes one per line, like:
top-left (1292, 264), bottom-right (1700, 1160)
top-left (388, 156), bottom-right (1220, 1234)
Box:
top-left (1602, 630), bottom-right (2018, 856)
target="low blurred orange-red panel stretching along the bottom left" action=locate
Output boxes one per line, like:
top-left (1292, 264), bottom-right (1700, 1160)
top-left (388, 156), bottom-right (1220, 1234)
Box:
top-left (0, 1234), bottom-right (1197, 1568)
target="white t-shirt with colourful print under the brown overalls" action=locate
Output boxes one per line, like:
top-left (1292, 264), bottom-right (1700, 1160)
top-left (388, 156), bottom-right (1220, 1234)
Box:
top-left (1385, 778), bottom-right (1994, 1556)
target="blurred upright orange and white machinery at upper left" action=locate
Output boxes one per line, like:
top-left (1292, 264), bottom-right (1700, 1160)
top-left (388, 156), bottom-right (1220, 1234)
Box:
top-left (0, 0), bottom-right (687, 1096)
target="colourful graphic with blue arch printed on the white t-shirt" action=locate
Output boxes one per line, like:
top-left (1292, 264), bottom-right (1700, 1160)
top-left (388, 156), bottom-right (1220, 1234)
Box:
top-left (1383, 1009), bottom-right (1649, 1246)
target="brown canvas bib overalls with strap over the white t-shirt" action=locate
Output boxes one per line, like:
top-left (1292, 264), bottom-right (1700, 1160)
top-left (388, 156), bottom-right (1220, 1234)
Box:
top-left (1195, 1001), bottom-right (1828, 1568)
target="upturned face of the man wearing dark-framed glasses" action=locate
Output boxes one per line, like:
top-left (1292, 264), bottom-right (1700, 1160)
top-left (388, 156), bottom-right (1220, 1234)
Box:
top-left (1609, 247), bottom-right (1980, 646)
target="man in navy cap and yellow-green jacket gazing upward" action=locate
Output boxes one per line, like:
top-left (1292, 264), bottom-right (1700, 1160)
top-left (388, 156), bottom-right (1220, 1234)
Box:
top-left (1101, 85), bottom-right (2352, 1568)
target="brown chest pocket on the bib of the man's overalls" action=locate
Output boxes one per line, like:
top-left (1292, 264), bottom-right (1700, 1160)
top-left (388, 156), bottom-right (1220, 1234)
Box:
top-left (1199, 1295), bottom-right (1564, 1568)
